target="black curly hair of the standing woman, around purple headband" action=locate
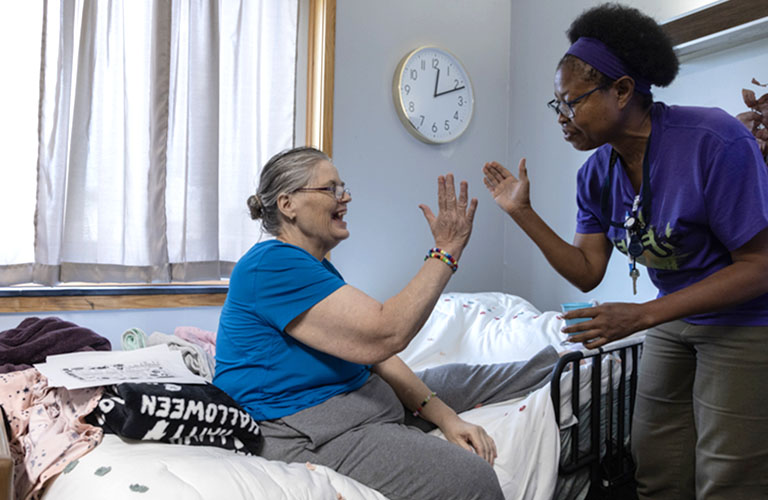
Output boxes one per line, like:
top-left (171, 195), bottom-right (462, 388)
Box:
top-left (558, 3), bottom-right (680, 104)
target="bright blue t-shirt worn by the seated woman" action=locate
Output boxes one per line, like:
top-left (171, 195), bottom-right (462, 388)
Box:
top-left (213, 240), bottom-right (370, 420)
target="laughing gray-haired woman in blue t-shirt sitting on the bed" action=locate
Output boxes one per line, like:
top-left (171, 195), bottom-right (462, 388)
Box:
top-left (214, 148), bottom-right (557, 500)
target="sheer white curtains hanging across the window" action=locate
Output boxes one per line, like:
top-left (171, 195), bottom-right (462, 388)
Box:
top-left (0, 0), bottom-right (298, 284)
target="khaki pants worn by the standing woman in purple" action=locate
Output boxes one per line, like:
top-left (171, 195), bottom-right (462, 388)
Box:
top-left (632, 321), bottom-right (768, 500)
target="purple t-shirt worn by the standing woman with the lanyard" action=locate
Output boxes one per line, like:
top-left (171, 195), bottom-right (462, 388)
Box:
top-left (576, 102), bottom-right (768, 325)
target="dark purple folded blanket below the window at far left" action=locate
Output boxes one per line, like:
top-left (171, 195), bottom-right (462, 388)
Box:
top-left (0, 317), bottom-right (112, 373)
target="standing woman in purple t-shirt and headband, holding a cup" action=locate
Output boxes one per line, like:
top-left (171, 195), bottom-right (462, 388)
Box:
top-left (483, 4), bottom-right (768, 499)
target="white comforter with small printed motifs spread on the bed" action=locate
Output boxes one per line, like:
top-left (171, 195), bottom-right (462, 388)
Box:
top-left (43, 293), bottom-right (608, 500)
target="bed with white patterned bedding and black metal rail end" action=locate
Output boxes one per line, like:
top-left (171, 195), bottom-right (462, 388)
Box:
top-left (0, 293), bottom-right (642, 500)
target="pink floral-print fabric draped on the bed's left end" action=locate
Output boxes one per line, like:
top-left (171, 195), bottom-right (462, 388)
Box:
top-left (0, 368), bottom-right (103, 500)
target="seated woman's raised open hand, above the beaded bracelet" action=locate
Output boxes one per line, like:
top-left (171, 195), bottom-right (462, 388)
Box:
top-left (419, 174), bottom-right (477, 259)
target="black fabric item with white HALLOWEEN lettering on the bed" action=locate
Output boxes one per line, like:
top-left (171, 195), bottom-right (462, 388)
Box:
top-left (86, 383), bottom-right (261, 455)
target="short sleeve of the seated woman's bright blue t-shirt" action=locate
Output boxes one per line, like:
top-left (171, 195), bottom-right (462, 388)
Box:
top-left (253, 245), bottom-right (345, 331)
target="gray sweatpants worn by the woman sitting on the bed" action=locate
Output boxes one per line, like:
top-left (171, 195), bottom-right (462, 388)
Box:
top-left (260, 347), bottom-right (558, 500)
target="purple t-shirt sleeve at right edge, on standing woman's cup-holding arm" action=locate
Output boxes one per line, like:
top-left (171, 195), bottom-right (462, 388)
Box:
top-left (704, 137), bottom-right (768, 251)
